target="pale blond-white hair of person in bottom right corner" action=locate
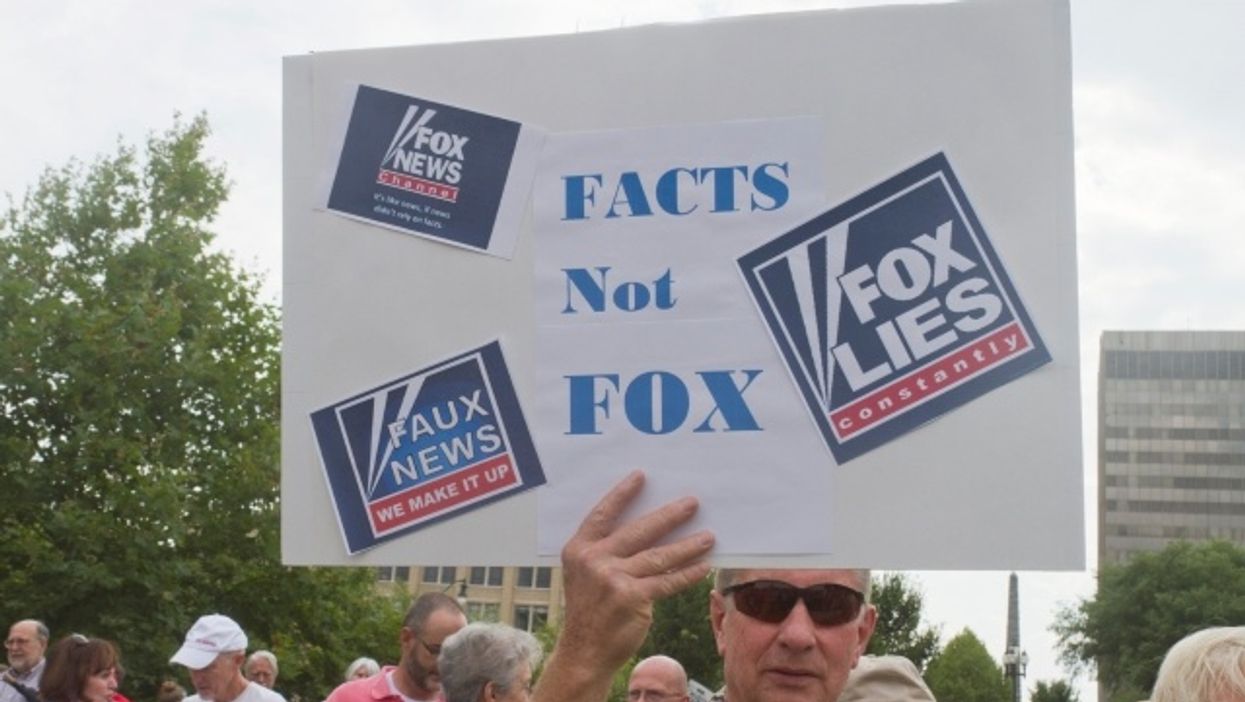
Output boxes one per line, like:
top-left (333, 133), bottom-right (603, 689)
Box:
top-left (1150, 626), bottom-right (1245, 702)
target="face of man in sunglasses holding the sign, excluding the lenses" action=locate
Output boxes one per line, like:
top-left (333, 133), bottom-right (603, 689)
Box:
top-left (710, 570), bottom-right (878, 702)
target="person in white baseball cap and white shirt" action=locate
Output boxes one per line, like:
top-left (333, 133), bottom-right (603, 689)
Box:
top-left (169, 614), bottom-right (285, 702)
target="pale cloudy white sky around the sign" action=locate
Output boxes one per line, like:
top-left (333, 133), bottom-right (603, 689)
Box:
top-left (0, 0), bottom-right (1245, 702)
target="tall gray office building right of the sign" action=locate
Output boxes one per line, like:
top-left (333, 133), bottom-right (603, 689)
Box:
top-left (1098, 331), bottom-right (1245, 564)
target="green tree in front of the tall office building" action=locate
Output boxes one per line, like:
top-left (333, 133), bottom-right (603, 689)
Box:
top-left (1052, 541), bottom-right (1245, 700)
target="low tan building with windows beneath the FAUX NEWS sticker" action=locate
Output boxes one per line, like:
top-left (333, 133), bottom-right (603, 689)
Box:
top-left (376, 565), bottom-right (563, 631)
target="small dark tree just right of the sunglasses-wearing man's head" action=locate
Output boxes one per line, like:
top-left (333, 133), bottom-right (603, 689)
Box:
top-left (867, 573), bottom-right (940, 671)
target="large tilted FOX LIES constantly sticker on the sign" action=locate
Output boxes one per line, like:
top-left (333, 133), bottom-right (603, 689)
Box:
top-left (738, 154), bottom-right (1051, 463)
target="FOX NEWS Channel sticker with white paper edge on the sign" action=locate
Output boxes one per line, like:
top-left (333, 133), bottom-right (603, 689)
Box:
top-left (327, 85), bottom-right (544, 258)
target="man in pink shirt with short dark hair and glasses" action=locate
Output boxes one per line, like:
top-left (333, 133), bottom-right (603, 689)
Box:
top-left (325, 592), bottom-right (467, 702)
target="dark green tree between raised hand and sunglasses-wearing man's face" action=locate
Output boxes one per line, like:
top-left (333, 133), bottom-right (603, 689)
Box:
top-left (637, 578), bottom-right (722, 690)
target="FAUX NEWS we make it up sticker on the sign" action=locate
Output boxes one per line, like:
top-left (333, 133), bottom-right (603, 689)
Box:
top-left (311, 341), bottom-right (545, 554)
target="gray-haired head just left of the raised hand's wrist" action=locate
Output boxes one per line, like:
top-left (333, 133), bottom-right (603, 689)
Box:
top-left (437, 622), bottom-right (540, 702)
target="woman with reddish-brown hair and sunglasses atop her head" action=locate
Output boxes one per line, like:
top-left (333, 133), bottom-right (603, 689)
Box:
top-left (39, 634), bottom-right (120, 702)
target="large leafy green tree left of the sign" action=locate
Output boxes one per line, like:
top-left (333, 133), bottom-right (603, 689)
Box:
top-left (0, 117), bottom-right (401, 698)
